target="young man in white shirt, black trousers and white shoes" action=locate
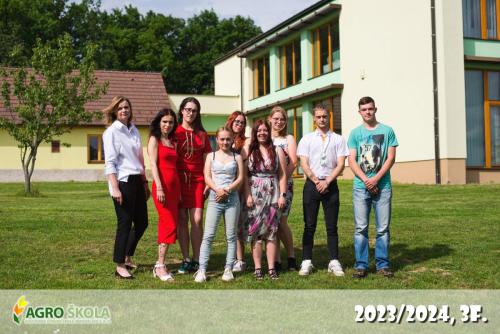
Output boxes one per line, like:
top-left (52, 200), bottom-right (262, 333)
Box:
top-left (297, 104), bottom-right (349, 276)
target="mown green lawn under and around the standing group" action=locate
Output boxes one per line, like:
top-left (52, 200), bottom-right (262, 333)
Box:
top-left (0, 180), bottom-right (500, 289)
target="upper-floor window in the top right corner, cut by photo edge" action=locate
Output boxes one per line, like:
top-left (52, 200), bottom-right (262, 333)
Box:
top-left (462, 0), bottom-right (500, 39)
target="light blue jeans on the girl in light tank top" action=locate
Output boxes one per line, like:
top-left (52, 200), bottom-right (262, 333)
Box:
top-left (200, 191), bottom-right (240, 270)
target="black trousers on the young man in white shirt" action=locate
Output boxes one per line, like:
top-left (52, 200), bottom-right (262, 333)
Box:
top-left (302, 179), bottom-right (340, 260)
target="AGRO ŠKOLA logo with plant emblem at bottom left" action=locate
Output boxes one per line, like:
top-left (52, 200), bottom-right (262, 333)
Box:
top-left (12, 296), bottom-right (111, 326)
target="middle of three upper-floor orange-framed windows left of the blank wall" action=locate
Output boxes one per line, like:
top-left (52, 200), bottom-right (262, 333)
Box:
top-left (279, 40), bottom-right (302, 88)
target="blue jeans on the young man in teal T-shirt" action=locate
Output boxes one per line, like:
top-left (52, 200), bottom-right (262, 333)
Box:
top-left (352, 188), bottom-right (392, 270)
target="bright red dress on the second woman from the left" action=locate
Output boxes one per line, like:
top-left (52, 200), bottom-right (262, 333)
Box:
top-left (152, 140), bottom-right (180, 244)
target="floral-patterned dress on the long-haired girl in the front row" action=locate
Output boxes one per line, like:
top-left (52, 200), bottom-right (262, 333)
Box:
top-left (248, 153), bottom-right (280, 242)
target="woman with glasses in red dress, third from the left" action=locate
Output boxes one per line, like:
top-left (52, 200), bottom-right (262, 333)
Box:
top-left (175, 97), bottom-right (212, 274)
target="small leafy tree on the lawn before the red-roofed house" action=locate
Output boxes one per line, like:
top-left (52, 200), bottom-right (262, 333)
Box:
top-left (0, 35), bottom-right (107, 195)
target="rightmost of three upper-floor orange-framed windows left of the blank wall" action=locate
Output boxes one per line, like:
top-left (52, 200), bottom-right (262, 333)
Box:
top-left (311, 21), bottom-right (340, 77)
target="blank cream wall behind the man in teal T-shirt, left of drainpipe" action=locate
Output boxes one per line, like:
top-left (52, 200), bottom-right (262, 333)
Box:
top-left (338, 0), bottom-right (434, 162)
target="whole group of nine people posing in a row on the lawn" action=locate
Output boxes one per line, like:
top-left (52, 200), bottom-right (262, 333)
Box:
top-left (103, 96), bottom-right (398, 282)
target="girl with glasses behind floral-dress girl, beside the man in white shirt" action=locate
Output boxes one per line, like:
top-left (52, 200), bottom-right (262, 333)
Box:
top-left (268, 106), bottom-right (297, 270)
